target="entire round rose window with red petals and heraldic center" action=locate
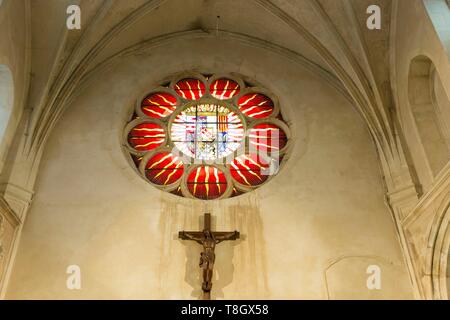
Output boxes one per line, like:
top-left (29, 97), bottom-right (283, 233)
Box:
top-left (124, 74), bottom-right (289, 200)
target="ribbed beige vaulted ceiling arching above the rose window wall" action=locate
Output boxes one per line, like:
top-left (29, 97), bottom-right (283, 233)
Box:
top-left (22, 0), bottom-right (402, 189)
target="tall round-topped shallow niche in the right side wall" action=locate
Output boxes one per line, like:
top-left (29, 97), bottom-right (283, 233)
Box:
top-left (408, 56), bottom-right (450, 182)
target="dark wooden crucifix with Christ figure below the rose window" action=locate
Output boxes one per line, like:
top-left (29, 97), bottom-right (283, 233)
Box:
top-left (178, 213), bottom-right (239, 300)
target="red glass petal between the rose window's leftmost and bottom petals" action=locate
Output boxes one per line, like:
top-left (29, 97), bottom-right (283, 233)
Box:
top-left (145, 152), bottom-right (184, 186)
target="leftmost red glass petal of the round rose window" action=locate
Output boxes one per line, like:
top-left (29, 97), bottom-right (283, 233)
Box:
top-left (128, 123), bottom-right (166, 152)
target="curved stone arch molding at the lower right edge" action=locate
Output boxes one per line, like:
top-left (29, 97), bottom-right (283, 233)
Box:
top-left (427, 192), bottom-right (450, 300)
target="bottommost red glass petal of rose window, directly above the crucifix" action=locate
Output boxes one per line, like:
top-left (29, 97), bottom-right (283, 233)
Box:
top-left (187, 166), bottom-right (228, 200)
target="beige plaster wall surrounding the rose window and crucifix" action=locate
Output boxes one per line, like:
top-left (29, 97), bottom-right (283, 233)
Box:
top-left (6, 39), bottom-right (412, 299)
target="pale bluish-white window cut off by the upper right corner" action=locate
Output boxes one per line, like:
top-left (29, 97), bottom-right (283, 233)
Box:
top-left (424, 0), bottom-right (450, 58)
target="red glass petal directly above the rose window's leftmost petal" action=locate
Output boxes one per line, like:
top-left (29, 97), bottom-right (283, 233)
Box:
top-left (141, 92), bottom-right (177, 119)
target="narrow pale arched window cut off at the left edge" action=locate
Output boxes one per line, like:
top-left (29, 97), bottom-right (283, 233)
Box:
top-left (0, 66), bottom-right (14, 148)
